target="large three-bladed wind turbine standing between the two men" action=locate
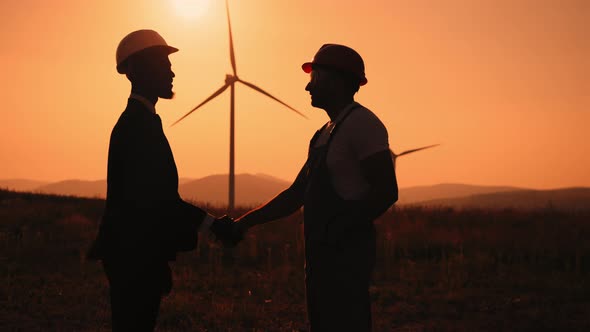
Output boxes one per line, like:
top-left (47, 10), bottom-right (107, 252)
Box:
top-left (172, 0), bottom-right (307, 212)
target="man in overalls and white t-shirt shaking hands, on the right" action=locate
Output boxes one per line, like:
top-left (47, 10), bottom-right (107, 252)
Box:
top-left (236, 44), bottom-right (398, 332)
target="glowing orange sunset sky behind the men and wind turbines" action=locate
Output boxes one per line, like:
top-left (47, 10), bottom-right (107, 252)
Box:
top-left (0, 0), bottom-right (590, 188)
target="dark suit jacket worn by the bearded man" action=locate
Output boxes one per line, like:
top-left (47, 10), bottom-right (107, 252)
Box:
top-left (88, 98), bottom-right (206, 260)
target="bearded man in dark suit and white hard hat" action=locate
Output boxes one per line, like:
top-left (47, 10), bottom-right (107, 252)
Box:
top-left (88, 30), bottom-right (239, 331)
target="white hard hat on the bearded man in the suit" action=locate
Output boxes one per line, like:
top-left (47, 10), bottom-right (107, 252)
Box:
top-left (117, 30), bottom-right (178, 74)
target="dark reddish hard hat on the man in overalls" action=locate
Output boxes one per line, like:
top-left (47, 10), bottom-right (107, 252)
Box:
top-left (301, 44), bottom-right (367, 85)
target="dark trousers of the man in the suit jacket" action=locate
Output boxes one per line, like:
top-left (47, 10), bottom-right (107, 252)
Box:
top-left (103, 261), bottom-right (171, 332)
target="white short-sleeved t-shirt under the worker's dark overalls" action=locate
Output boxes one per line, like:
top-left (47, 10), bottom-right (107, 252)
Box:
top-left (315, 102), bottom-right (389, 200)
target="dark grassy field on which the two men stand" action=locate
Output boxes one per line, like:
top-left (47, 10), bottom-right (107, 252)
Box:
top-left (0, 191), bottom-right (590, 332)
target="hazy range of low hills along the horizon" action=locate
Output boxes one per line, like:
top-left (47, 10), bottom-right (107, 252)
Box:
top-left (0, 174), bottom-right (590, 210)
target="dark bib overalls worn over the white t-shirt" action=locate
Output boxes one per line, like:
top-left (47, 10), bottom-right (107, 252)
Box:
top-left (304, 109), bottom-right (375, 332)
